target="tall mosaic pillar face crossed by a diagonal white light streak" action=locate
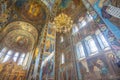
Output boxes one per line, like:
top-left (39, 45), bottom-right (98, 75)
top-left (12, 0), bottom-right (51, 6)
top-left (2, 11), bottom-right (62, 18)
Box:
top-left (40, 23), bottom-right (55, 80)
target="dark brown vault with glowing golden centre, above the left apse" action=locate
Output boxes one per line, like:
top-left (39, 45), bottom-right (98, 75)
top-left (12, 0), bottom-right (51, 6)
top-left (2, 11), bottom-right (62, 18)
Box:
top-left (15, 0), bottom-right (49, 32)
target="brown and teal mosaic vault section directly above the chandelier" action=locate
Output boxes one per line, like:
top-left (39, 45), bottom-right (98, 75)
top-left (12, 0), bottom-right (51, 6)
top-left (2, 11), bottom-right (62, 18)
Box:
top-left (58, 0), bottom-right (86, 22)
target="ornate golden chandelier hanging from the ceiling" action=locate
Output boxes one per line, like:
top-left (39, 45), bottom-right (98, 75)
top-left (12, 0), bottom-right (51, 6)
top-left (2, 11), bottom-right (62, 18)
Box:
top-left (53, 13), bottom-right (73, 33)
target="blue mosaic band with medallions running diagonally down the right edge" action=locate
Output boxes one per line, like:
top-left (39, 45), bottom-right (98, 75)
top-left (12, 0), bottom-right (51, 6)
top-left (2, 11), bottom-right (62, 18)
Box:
top-left (82, 0), bottom-right (120, 56)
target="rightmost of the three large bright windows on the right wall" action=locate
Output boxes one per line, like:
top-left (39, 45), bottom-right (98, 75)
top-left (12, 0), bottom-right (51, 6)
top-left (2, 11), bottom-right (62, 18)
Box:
top-left (96, 30), bottom-right (110, 49)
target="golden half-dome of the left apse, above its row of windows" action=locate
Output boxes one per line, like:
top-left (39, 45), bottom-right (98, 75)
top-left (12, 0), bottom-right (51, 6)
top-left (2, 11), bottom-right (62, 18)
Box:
top-left (3, 30), bottom-right (35, 53)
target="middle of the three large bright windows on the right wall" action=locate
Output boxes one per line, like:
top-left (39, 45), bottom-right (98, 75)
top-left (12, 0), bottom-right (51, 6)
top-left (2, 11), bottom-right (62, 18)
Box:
top-left (86, 36), bottom-right (98, 54)
